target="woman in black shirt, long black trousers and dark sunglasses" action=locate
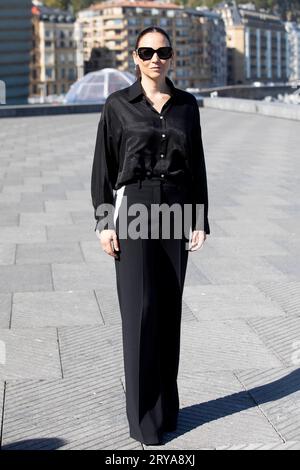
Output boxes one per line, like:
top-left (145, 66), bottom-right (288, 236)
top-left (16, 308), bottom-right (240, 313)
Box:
top-left (91, 27), bottom-right (210, 445)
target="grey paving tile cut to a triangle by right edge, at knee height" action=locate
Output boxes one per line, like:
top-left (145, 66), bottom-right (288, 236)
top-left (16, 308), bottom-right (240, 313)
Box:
top-left (256, 281), bottom-right (300, 316)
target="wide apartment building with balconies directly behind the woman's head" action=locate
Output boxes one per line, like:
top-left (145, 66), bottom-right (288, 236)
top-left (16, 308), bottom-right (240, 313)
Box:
top-left (77, 0), bottom-right (226, 88)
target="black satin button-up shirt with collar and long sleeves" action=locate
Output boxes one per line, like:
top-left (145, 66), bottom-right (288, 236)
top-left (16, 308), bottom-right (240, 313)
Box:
top-left (91, 77), bottom-right (210, 234)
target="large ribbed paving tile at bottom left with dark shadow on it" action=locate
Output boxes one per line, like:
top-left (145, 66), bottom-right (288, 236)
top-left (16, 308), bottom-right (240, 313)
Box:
top-left (2, 373), bottom-right (141, 450)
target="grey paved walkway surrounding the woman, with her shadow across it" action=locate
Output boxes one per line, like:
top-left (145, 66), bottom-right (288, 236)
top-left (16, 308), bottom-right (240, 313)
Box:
top-left (0, 109), bottom-right (300, 449)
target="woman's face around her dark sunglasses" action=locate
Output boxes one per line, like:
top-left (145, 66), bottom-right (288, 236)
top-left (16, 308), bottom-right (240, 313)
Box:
top-left (133, 32), bottom-right (172, 79)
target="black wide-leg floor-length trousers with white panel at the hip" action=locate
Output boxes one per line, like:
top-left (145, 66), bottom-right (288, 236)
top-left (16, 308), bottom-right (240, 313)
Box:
top-left (115, 180), bottom-right (189, 444)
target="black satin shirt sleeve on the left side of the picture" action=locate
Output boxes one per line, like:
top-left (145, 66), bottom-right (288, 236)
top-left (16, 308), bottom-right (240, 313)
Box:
top-left (91, 101), bottom-right (118, 231)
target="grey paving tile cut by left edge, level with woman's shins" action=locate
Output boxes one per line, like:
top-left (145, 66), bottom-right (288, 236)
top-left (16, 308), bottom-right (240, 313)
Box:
top-left (0, 328), bottom-right (61, 380)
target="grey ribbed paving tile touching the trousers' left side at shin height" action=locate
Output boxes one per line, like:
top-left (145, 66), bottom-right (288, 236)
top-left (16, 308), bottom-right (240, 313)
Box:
top-left (58, 324), bottom-right (124, 382)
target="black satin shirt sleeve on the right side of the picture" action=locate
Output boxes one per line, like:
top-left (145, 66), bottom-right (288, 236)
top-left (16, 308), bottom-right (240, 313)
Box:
top-left (192, 101), bottom-right (210, 234)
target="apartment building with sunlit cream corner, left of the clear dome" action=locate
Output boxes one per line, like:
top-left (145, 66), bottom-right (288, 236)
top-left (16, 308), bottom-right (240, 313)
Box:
top-left (30, 2), bottom-right (78, 100)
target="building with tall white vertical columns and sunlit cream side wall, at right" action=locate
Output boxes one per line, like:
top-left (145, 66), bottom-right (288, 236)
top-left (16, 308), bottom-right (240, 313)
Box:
top-left (216, 1), bottom-right (289, 84)
